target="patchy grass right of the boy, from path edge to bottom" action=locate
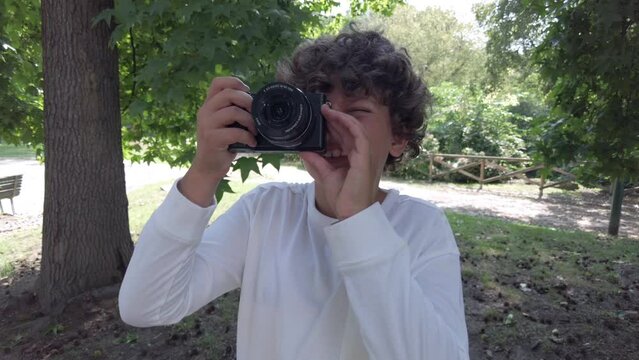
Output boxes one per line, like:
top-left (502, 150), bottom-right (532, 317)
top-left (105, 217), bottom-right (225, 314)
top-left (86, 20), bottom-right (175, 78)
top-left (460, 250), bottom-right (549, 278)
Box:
top-left (447, 212), bottom-right (639, 358)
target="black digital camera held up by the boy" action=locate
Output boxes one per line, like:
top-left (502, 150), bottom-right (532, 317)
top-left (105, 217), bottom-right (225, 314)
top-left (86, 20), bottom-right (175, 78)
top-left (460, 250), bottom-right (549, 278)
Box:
top-left (229, 82), bottom-right (326, 152)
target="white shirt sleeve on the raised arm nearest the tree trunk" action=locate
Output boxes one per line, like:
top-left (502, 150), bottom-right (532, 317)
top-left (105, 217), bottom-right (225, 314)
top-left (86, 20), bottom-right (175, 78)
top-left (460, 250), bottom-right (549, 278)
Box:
top-left (119, 182), bottom-right (250, 327)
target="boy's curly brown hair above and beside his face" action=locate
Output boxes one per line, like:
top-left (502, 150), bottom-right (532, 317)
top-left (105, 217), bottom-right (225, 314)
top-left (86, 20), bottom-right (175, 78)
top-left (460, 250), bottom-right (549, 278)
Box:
top-left (276, 25), bottom-right (432, 167)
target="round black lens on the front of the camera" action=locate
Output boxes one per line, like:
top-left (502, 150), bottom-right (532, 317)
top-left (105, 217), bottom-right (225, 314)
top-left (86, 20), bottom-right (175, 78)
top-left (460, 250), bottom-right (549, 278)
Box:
top-left (252, 83), bottom-right (311, 148)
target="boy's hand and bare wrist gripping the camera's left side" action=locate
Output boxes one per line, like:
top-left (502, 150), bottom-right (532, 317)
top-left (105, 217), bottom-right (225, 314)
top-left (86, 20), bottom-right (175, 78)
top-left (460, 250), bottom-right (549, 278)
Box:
top-left (179, 77), bottom-right (257, 206)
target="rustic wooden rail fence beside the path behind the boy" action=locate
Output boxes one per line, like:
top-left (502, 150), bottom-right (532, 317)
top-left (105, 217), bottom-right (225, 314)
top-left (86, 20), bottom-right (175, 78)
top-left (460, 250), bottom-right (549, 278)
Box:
top-left (428, 154), bottom-right (575, 199)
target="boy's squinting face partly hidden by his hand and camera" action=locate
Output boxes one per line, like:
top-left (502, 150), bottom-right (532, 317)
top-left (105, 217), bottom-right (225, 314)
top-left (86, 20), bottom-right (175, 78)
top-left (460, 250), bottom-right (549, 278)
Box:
top-left (318, 81), bottom-right (407, 181)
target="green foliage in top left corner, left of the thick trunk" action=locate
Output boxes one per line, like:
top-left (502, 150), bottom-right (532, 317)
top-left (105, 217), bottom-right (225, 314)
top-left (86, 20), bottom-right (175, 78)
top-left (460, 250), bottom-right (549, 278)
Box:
top-left (0, 0), bottom-right (44, 155)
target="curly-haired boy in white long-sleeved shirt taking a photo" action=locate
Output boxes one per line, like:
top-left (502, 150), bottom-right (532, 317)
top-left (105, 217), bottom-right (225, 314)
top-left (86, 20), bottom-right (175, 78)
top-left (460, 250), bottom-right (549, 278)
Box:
top-left (120, 31), bottom-right (468, 360)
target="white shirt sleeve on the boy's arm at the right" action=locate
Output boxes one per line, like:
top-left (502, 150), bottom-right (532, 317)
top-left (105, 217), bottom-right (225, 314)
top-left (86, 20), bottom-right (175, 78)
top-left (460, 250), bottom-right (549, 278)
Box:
top-left (325, 203), bottom-right (469, 360)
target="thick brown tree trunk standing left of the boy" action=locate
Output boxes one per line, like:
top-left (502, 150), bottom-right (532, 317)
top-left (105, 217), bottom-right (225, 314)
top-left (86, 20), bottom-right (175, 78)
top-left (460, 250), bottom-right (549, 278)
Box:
top-left (37, 0), bottom-right (133, 314)
